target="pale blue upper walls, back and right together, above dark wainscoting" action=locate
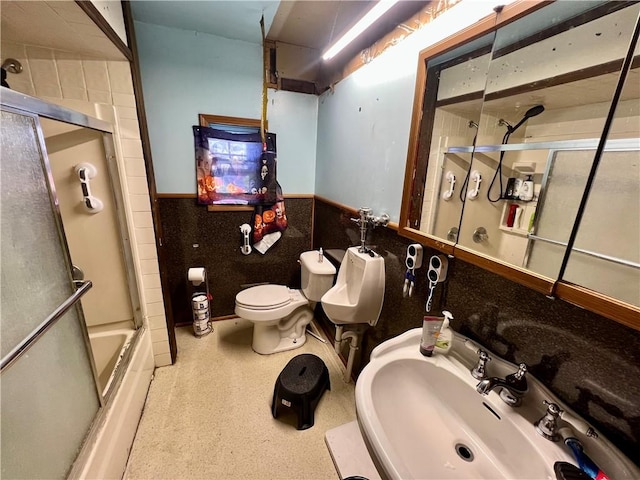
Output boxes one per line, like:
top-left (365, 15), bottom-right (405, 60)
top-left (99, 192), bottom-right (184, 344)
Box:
top-left (135, 2), bottom-right (500, 211)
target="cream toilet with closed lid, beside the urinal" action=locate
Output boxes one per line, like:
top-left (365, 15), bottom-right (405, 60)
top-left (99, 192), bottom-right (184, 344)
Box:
top-left (235, 250), bottom-right (336, 355)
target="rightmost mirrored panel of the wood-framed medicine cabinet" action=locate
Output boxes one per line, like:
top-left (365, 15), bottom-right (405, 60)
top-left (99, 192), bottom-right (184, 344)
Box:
top-left (558, 24), bottom-right (640, 326)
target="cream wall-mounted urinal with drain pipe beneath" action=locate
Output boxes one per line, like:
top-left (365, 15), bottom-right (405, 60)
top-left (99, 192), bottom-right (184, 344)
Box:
top-left (320, 247), bottom-right (385, 382)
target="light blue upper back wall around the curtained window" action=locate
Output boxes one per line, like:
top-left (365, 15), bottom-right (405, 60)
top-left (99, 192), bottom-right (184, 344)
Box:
top-left (135, 22), bottom-right (318, 194)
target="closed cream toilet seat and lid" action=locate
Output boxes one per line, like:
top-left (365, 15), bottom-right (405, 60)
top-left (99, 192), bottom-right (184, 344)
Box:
top-left (235, 285), bottom-right (309, 322)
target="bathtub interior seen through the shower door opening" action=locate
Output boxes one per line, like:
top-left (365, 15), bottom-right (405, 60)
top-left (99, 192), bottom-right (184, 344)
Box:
top-left (89, 328), bottom-right (135, 396)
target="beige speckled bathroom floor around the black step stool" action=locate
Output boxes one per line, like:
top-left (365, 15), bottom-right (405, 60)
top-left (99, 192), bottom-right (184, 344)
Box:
top-left (124, 319), bottom-right (356, 480)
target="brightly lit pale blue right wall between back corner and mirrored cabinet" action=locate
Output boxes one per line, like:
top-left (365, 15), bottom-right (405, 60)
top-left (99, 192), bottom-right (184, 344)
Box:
top-left (315, 2), bottom-right (504, 222)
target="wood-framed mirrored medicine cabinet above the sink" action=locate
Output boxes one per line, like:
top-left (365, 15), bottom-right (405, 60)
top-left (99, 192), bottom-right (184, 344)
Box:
top-left (399, 1), bottom-right (640, 329)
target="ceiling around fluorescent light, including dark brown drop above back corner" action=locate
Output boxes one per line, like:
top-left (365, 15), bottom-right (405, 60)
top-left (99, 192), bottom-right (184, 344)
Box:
top-left (131, 0), bottom-right (430, 88)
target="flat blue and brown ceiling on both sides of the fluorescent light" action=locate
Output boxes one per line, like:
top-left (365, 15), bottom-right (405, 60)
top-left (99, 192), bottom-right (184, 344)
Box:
top-left (131, 0), bottom-right (429, 60)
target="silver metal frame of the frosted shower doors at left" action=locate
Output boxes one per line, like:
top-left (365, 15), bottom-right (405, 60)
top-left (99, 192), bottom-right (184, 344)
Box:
top-left (0, 87), bottom-right (144, 478)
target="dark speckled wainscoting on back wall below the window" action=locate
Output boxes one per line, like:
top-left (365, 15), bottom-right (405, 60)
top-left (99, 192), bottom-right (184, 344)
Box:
top-left (158, 197), bottom-right (313, 324)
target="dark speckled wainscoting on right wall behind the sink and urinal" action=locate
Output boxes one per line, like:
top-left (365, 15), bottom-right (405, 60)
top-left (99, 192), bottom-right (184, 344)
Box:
top-left (313, 199), bottom-right (640, 465)
